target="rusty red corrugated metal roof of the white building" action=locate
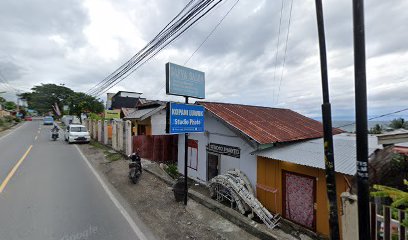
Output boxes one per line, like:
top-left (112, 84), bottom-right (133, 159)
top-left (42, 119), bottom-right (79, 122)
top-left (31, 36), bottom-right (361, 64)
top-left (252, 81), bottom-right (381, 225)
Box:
top-left (197, 102), bottom-right (342, 144)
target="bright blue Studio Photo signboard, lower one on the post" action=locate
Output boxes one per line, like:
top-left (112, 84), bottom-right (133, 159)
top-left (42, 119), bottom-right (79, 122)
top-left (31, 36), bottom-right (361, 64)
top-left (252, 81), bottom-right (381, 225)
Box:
top-left (166, 103), bottom-right (204, 134)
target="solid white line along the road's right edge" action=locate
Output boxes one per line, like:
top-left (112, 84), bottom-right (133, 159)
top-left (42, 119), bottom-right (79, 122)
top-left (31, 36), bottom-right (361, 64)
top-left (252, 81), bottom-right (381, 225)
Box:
top-left (75, 145), bottom-right (147, 240)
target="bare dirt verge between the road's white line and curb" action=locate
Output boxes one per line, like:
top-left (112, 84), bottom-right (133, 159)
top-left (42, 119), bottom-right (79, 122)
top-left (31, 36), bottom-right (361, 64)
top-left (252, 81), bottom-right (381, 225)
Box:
top-left (79, 144), bottom-right (257, 240)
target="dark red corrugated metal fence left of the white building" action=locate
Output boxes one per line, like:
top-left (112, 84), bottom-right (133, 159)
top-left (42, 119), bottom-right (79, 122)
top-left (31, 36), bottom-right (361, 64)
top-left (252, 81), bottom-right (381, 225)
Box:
top-left (133, 135), bottom-right (178, 163)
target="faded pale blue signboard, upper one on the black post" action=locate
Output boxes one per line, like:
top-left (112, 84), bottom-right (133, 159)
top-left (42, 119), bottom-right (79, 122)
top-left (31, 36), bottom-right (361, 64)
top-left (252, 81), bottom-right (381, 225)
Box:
top-left (166, 63), bottom-right (205, 99)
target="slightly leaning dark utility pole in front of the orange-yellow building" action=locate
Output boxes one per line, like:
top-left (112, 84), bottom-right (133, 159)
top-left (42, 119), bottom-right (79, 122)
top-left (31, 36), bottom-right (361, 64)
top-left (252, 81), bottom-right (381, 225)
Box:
top-left (316, 0), bottom-right (340, 240)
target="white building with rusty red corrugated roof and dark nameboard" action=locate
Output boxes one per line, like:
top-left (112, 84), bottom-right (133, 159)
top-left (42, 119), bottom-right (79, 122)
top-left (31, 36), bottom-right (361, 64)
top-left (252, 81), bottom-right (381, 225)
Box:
top-left (178, 102), bottom-right (334, 188)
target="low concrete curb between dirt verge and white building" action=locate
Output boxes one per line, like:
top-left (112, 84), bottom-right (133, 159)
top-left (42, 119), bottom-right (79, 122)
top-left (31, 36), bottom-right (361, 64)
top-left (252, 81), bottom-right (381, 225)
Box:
top-left (143, 167), bottom-right (280, 240)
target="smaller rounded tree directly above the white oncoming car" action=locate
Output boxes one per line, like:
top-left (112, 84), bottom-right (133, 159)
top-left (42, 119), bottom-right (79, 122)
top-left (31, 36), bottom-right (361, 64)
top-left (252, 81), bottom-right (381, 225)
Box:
top-left (67, 92), bottom-right (104, 116)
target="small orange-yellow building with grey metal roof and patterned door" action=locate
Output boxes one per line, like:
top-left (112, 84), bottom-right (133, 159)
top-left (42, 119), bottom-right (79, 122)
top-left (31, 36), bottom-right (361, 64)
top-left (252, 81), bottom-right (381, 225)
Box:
top-left (255, 134), bottom-right (381, 237)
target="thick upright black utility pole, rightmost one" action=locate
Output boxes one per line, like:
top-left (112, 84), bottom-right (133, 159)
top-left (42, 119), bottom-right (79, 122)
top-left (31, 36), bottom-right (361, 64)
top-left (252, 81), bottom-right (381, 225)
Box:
top-left (353, 0), bottom-right (374, 240)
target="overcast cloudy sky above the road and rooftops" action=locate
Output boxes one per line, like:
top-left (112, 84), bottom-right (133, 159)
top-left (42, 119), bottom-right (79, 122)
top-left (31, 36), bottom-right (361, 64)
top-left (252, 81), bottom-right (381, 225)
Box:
top-left (0, 0), bottom-right (408, 119)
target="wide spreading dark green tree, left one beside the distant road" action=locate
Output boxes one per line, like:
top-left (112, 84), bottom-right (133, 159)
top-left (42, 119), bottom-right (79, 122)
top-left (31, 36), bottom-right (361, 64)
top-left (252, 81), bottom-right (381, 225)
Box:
top-left (19, 84), bottom-right (74, 114)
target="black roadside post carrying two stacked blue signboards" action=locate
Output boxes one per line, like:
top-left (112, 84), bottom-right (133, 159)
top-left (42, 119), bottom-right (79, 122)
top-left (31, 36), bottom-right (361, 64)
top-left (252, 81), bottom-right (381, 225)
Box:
top-left (166, 63), bottom-right (205, 205)
